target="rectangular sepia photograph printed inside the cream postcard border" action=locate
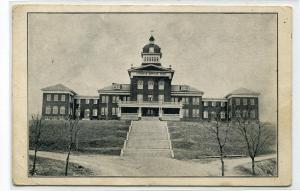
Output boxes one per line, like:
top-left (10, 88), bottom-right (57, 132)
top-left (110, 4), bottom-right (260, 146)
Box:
top-left (11, 4), bottom-right (290, 187)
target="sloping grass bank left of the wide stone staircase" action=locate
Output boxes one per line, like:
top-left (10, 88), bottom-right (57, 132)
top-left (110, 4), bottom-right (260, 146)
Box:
top-left (29, 120), bottom-right (130, 155)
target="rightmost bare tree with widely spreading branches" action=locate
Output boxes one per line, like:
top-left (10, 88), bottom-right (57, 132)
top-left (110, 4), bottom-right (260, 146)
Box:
top-left (236, 115), bottom-right (272, 175)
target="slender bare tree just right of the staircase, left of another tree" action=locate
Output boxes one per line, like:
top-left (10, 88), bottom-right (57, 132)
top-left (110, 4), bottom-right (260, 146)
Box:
top-left (207, 112), bottom-right (231, 176)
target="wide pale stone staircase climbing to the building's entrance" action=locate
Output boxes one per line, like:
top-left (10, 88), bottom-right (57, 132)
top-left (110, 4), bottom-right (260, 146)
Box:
top-left (121, 118), bottom-right (174, 157)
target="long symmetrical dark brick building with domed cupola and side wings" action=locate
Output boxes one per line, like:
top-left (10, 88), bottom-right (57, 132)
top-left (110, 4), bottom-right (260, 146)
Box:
top-left (42, 36), bottom-right (259, 121)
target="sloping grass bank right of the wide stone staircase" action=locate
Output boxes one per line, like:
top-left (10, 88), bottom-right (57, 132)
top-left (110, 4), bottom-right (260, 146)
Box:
top-left (168, 121), bottom-right (276, 159)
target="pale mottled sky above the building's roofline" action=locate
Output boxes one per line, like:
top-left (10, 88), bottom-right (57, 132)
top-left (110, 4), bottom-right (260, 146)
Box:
top-left (28, 13), bottom-right (277, 122)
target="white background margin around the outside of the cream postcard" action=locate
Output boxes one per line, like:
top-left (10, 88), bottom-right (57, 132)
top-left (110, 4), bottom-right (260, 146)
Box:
top-left (0, 0), bottom-right (300, 191)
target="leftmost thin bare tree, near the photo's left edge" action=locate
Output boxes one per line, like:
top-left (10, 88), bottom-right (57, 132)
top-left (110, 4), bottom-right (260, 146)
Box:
top-left (30, 114), bottom-right (42, 176)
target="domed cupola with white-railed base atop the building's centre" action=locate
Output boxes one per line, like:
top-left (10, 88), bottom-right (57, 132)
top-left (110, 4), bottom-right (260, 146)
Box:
top-left (141, 35), bottom-right (162, 66)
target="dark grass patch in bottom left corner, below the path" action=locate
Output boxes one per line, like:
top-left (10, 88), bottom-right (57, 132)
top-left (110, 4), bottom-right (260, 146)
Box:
top-left (28, 156), bottom-right (93, 176)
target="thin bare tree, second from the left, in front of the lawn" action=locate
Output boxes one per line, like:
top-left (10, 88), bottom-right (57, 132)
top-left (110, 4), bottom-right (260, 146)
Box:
top-left (65, 117), bottom-right (80, 176)
